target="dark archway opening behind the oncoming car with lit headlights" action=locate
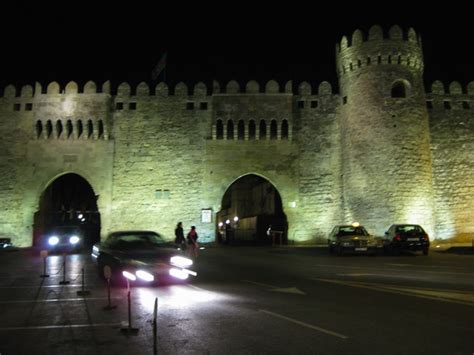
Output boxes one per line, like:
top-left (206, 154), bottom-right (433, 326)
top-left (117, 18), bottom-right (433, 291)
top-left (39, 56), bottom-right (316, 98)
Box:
top-left (33, 173), bottom-right (100, 248)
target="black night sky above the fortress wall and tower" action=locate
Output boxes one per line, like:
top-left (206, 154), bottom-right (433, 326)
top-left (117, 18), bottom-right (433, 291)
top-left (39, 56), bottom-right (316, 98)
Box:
top-left (0, 1), bottom-right (474, 93)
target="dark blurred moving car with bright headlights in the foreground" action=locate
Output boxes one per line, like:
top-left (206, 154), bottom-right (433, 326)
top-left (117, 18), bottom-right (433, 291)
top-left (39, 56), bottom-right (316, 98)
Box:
top-left (92, 231), bottom-right (196, 284)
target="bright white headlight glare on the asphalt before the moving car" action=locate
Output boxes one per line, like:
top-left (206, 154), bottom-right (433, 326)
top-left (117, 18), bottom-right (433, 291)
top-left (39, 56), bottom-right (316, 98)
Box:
top-left (134, 285), bottom-right (229, 312)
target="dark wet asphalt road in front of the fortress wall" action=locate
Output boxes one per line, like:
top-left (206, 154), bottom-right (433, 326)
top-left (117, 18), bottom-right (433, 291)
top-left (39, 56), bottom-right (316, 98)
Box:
top-left (0, 247), bottom-right (474, 355)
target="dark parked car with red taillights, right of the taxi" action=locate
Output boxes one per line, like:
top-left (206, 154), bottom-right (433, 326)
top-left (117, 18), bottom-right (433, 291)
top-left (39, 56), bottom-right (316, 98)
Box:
top-left (385, 224), bottom-right (430, 255)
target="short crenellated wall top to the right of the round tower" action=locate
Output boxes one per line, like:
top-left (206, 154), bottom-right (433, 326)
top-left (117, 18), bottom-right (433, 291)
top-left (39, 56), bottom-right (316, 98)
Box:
top-left (426, 80), bottom-right (474, 110)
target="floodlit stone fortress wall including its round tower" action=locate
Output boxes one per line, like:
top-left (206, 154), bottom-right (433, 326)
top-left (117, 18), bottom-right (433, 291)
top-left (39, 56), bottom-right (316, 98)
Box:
top-left (0, 26), bottom-right (474, 246)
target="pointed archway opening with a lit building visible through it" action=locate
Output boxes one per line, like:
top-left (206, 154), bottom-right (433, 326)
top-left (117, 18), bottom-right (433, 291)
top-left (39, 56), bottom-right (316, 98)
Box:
top-left (216, 174), bottom-right (288, 245)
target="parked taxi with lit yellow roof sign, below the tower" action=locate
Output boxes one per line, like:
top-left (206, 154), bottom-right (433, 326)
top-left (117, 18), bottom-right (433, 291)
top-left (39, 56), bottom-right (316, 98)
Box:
top-left (328, 223), bottom-right (383, 255)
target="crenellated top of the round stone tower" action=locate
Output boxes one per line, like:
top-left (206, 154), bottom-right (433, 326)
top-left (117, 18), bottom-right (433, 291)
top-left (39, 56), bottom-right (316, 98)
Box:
top-left (336, 25), bottom-right (423, 77)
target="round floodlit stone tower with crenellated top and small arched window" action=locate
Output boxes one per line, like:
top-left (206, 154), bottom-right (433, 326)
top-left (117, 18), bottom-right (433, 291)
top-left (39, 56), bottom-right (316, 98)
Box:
top-left (336, 26), bottom-right (434, 239)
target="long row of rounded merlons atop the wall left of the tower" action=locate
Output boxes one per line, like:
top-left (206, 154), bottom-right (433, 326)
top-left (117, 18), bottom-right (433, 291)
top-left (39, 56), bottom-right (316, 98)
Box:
top-left (2, 80), bottom-right (338, 99)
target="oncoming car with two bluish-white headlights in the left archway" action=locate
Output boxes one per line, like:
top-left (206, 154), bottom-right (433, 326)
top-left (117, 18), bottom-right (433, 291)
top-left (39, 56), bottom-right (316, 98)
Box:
top-left (41, 226), bottom-right (84, 253)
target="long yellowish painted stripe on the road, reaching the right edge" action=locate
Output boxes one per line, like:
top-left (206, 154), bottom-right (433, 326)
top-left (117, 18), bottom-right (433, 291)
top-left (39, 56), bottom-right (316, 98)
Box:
top-left (311, 279), bottom-right (474, 307)
